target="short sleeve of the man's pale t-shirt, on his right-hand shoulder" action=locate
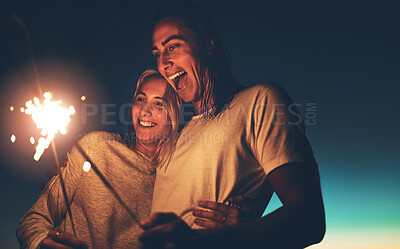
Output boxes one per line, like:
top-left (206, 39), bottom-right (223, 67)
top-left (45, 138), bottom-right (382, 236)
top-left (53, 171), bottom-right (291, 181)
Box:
top-left (250, 85), bottom-right (315, 174)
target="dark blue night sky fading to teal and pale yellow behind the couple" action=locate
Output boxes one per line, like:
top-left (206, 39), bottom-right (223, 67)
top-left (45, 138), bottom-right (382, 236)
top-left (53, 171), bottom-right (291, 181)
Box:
top-left (0, 0), bottom-right (400, 248)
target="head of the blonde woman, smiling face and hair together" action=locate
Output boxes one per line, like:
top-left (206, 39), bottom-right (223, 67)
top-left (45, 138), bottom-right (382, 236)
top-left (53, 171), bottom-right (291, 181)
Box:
top-left (130, 69), bottom-right (181, 166)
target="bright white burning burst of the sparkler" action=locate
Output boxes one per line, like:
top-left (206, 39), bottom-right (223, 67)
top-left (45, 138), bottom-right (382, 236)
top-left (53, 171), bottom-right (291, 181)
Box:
top-left (21, 92), bottom-right (75, 161)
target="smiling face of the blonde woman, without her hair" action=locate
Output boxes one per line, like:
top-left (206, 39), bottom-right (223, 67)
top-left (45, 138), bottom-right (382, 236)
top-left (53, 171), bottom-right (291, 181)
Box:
top-left (132, 77), bottom-right (172, 148)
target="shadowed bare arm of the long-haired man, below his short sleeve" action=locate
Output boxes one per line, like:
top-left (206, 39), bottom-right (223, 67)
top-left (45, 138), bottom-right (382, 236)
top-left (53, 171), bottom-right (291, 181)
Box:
top-left (197, 163), bottom-right (325, 248)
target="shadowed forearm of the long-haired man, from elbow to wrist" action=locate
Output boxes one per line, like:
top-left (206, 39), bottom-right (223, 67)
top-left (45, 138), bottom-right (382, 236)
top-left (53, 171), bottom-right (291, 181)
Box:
top-left (196, 202), bottom-right (325, 249)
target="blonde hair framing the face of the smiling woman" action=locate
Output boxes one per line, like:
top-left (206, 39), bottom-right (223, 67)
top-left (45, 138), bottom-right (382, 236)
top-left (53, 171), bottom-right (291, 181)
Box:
top-left (128, 69), bottom-right (181, 167)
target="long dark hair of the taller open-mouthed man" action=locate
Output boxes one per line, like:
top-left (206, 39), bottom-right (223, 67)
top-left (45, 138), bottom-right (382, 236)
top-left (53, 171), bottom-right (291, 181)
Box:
top-left (152, 2), bottom-right (243, 116)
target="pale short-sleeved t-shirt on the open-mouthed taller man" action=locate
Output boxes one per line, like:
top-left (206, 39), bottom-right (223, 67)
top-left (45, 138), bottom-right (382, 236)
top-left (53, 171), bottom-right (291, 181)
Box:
top-left (152, 85), bottom-right (314, 228)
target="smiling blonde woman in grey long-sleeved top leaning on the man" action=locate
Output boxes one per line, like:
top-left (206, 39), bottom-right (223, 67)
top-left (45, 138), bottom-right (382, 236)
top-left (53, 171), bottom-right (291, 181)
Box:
top-left (17, 70), bottom-right (180, 248)
